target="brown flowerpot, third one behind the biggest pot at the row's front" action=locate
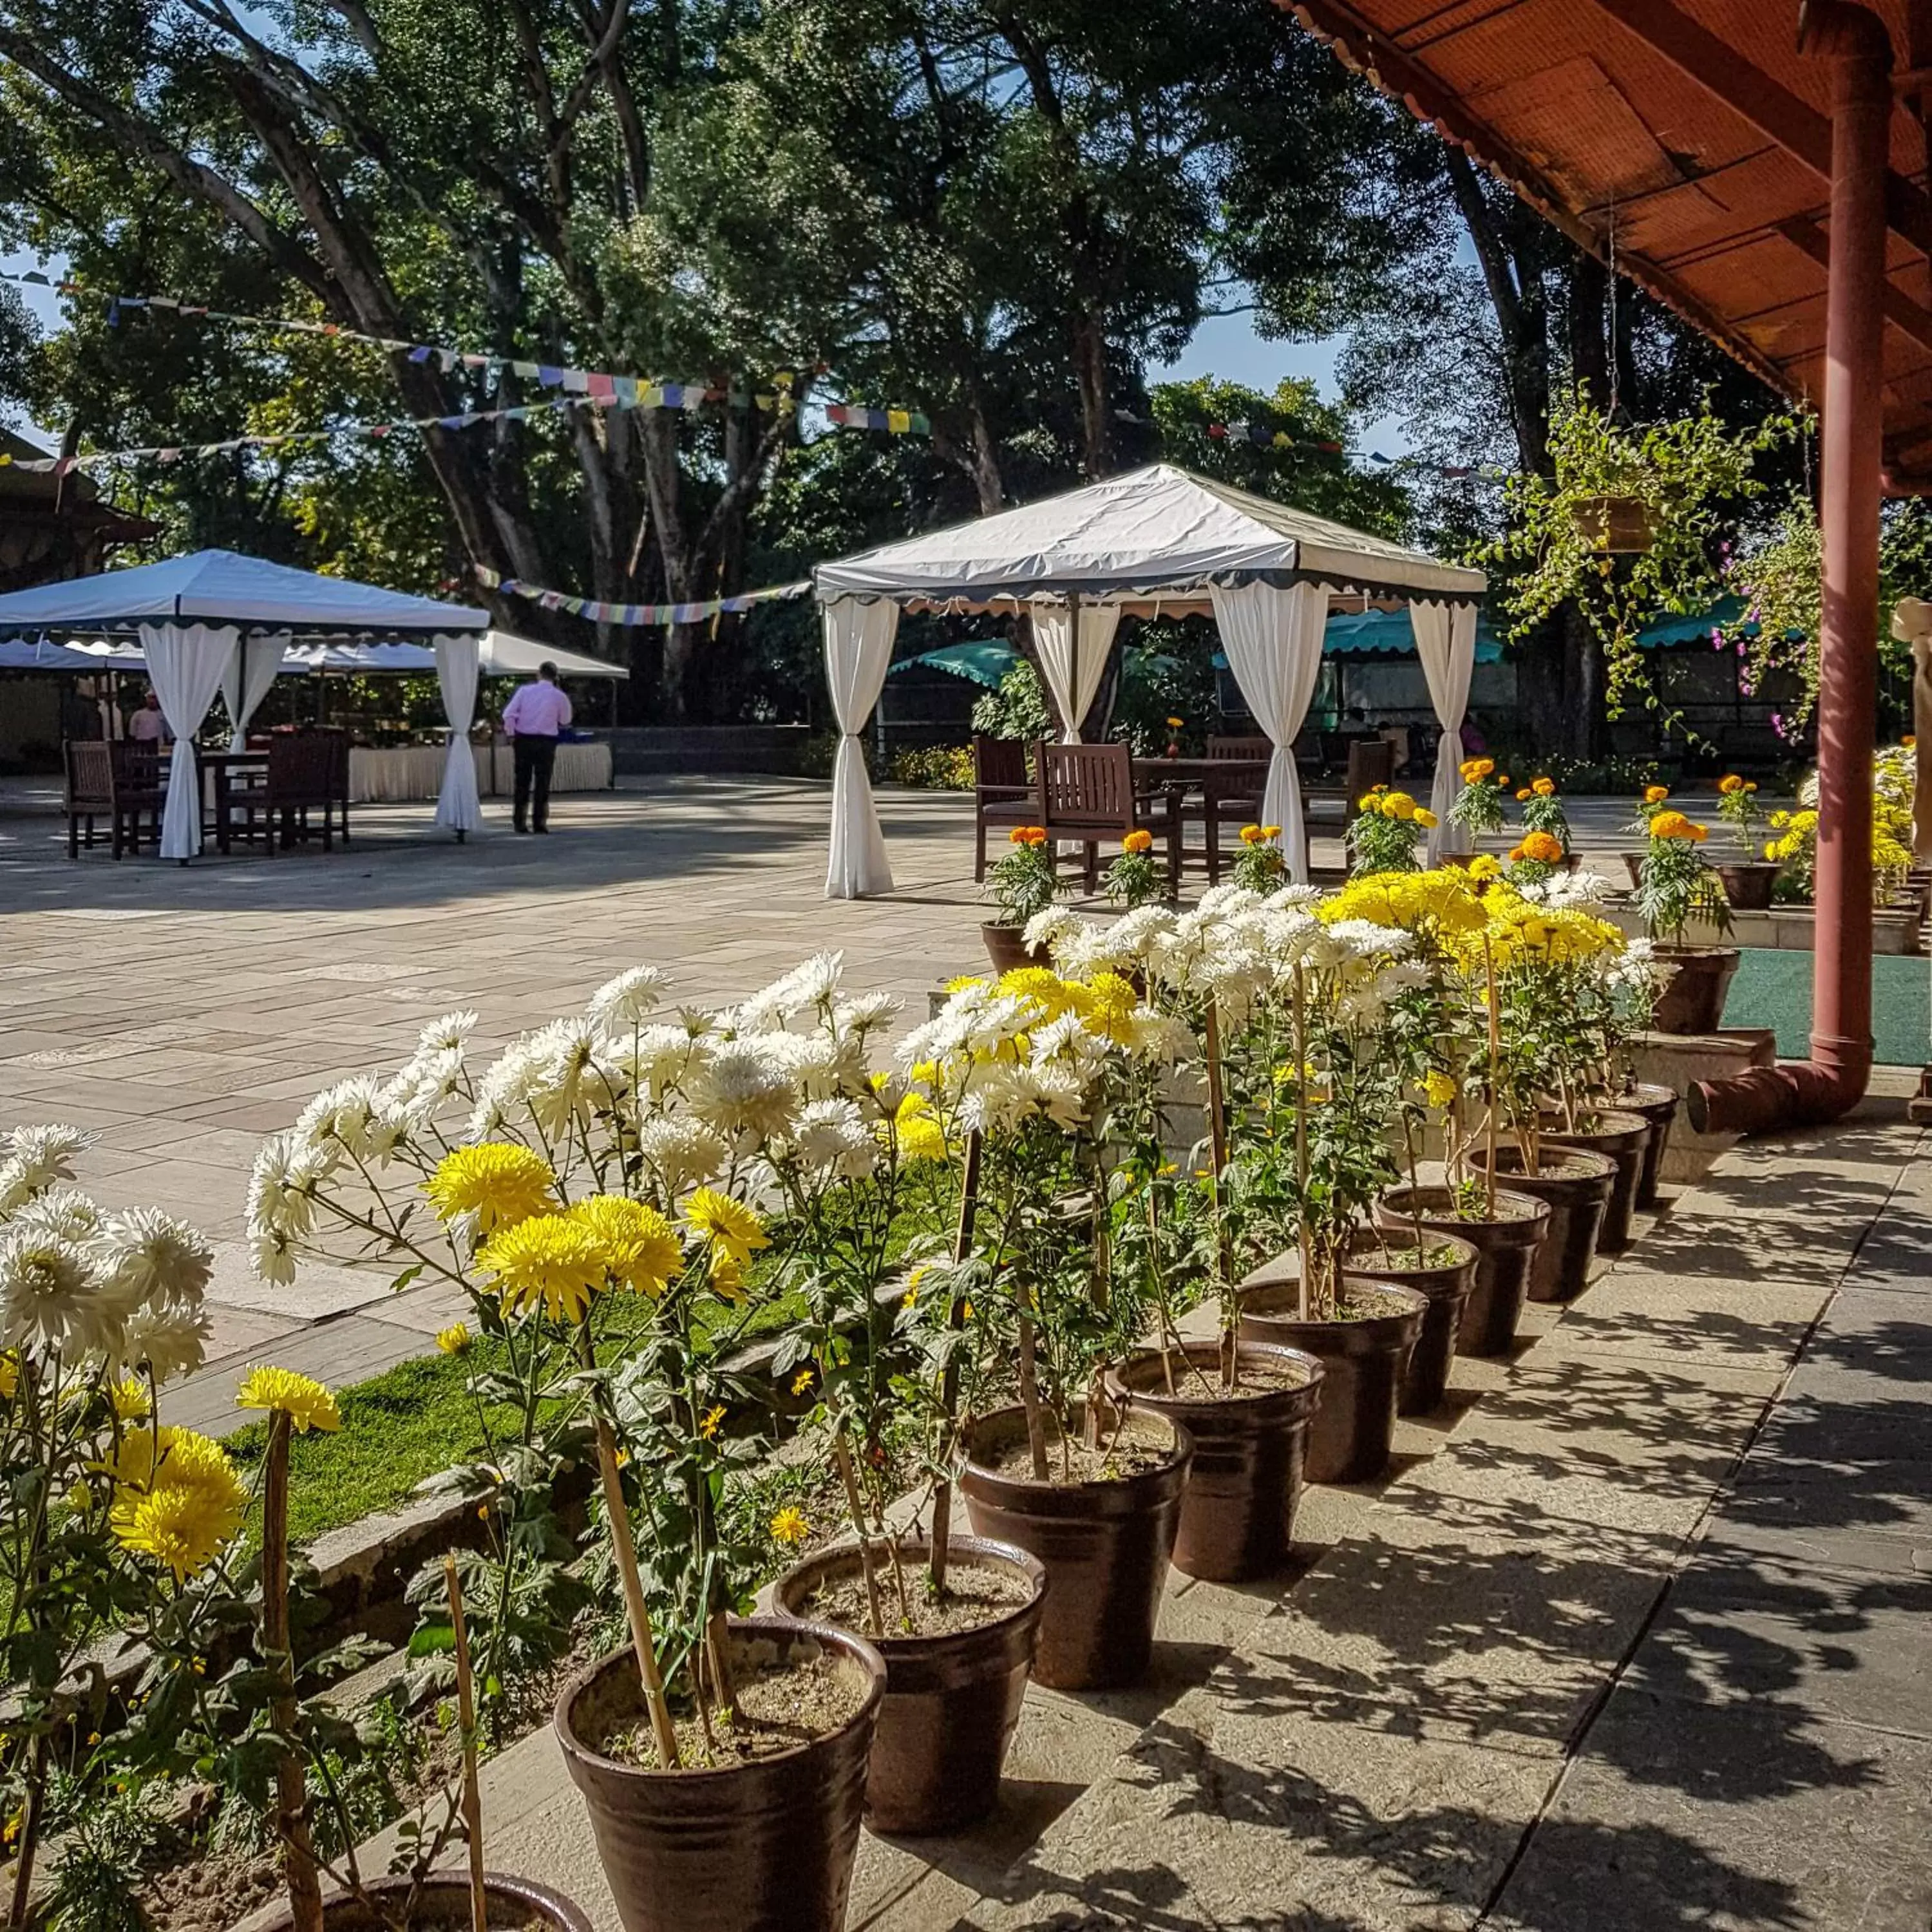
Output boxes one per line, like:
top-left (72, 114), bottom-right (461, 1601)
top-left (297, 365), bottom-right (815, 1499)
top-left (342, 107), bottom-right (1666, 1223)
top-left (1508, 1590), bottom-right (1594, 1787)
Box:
top-left (1107, 1341), bottom-right (1321, 1582)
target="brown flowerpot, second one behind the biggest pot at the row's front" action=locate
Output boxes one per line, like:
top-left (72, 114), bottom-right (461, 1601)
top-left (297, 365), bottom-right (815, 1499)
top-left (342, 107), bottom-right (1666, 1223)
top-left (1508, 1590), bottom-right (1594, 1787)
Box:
top-left (958, 1408), bottom-right (1194, 1690)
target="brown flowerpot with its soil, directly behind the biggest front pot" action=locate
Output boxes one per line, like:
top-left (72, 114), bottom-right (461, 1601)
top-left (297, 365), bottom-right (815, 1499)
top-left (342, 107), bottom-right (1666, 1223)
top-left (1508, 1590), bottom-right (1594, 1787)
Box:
top-left (777, 1536), bottom-right (1047, 1835)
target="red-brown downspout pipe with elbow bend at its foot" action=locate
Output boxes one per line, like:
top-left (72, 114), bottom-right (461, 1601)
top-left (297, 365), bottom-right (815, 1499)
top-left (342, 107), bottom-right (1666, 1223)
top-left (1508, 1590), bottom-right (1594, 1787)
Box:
top-left (1687, 0), bottom-right (1891, 1134)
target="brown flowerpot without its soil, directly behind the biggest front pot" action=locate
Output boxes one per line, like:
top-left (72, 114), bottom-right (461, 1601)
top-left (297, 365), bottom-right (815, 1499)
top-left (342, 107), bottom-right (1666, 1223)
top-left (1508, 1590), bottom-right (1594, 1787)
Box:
top-left (775, 1536), bottom-right (1047, 1835)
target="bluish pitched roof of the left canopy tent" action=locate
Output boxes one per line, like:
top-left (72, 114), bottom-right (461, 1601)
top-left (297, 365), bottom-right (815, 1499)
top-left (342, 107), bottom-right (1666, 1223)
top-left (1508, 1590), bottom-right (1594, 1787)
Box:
top-left (0, 551), bottom-right (489, 636)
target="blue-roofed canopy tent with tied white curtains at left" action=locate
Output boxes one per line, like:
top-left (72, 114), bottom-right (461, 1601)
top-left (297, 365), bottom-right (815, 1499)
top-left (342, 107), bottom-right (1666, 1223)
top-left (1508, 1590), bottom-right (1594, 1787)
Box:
top-left (0, 551), bottom-right (489, 864)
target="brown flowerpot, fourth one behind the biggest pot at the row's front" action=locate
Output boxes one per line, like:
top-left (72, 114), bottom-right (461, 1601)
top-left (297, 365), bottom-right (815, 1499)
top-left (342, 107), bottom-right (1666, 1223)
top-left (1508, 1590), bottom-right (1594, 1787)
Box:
top-left (1240, 1256), bottom-right (1430, 1482)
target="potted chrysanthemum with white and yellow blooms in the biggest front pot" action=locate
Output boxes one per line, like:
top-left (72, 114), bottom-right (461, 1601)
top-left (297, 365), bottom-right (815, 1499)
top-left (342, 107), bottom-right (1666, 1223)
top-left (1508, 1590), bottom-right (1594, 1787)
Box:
top-left (257, 968), bottom-right (885, 1932)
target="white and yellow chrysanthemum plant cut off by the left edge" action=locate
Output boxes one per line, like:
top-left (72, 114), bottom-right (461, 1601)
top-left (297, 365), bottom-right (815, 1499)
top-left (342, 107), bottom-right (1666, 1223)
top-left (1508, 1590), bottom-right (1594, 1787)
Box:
top-left (0, 1126), bottom-right (217, 1926)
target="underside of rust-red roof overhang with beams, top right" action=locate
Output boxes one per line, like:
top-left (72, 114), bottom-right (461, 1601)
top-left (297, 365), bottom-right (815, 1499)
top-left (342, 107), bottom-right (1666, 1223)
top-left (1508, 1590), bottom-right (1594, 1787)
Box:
top-left (1283, 0), bottom-right (1932, 489)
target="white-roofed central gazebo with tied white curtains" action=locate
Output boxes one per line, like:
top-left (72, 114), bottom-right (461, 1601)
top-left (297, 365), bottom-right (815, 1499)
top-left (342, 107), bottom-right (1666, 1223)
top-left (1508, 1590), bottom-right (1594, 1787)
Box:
top-left (813, 464), bottom-right (1488, 898)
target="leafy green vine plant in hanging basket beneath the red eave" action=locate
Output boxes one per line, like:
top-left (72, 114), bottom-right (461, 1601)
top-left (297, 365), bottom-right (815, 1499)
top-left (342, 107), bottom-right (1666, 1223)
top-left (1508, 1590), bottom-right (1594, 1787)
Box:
top-left (1478, 390), bottom-right (1804, 719)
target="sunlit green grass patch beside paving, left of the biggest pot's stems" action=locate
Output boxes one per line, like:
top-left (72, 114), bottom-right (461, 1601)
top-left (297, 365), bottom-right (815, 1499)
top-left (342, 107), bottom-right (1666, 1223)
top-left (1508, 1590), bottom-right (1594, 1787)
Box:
top-left (226, 1343), bottom-right (516, 1546)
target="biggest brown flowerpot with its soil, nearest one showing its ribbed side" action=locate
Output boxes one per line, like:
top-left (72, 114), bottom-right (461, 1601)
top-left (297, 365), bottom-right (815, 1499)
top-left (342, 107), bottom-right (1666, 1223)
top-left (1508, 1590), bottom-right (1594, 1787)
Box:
top-left (554, 1617), bottom-right (885, 1932)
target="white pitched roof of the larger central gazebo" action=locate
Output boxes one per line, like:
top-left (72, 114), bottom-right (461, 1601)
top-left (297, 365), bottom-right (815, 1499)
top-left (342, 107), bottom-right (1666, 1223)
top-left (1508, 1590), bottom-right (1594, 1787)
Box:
top-left (811, 464), bottom-right (1488, 605)
